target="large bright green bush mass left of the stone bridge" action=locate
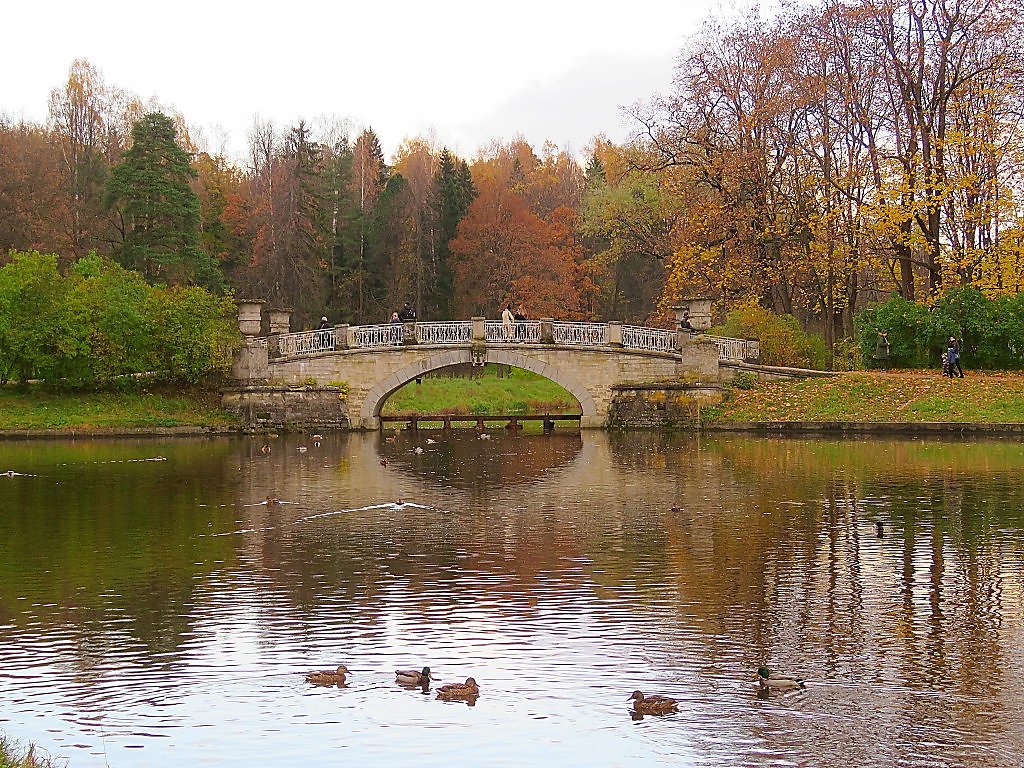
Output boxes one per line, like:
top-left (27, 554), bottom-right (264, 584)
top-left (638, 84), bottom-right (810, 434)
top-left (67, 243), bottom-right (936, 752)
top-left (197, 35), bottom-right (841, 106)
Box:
top-left (0, 252), bottom-right (240, 388)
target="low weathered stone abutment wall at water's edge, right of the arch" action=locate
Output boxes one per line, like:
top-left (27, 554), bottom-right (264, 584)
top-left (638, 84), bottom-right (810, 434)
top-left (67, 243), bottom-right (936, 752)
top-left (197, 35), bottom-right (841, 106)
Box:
top-left (608, 384), bottom-right (723, 429)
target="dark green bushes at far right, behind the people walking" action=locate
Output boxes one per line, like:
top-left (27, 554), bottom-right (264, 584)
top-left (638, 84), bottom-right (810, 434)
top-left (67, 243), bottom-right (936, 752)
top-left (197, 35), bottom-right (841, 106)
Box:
top-left (856, 286), bottom-right (1024, 371)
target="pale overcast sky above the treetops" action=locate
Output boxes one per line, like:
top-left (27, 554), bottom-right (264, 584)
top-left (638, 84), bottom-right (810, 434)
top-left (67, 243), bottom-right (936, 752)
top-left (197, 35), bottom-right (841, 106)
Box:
top-left (0, 0), bottom-right (732, 163)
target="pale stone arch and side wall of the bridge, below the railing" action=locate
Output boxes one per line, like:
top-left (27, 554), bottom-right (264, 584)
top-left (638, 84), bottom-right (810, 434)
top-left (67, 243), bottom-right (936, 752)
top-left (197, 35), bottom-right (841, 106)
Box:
top-left (253, 340), bottom-right (719, 429)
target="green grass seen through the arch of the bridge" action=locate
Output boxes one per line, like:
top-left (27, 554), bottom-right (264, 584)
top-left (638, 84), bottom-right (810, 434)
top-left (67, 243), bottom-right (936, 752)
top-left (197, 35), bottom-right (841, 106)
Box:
top-left (382, 366), bottom-right (580, 416)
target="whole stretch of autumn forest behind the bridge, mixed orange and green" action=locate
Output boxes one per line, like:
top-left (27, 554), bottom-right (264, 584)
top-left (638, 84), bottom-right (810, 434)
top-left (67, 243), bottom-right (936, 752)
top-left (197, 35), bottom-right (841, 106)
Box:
top-left (0, 0), bottom-right (1024, 354)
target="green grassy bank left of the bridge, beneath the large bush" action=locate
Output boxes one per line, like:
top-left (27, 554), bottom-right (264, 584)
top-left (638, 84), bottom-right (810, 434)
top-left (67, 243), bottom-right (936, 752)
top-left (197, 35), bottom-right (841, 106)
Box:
top-left (0, 387), bottom-right (236, 431)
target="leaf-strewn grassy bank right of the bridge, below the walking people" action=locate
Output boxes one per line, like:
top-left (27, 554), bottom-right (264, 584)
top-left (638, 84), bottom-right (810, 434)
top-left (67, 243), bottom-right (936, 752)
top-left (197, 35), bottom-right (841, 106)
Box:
top-left (703, 371), bottom-right (1024, 424)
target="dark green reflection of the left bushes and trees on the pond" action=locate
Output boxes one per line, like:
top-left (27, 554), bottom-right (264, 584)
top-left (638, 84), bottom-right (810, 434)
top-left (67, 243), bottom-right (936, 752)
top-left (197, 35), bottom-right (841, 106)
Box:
top-left (0, 440), bottom-right (233, 673)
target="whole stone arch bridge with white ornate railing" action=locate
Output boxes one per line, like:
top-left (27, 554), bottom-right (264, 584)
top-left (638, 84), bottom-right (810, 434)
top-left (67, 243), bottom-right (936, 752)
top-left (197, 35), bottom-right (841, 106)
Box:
top-left (225, 317), bottom-right (750, 429)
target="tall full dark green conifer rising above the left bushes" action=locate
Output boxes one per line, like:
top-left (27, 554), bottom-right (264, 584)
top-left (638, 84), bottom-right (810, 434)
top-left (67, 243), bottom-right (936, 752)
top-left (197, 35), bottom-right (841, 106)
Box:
top-left (106, 112), bottom-right (223, 288)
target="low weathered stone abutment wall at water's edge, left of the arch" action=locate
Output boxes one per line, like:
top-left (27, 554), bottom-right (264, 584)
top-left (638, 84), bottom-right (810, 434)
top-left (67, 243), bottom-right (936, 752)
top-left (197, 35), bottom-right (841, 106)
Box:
top-left (221, 386), bottom-right (349, 429)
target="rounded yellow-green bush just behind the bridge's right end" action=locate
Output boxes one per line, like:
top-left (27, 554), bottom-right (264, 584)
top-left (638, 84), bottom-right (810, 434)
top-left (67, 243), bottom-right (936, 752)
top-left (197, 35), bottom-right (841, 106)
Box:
top-left (713, 306), bottom-right (828, 369)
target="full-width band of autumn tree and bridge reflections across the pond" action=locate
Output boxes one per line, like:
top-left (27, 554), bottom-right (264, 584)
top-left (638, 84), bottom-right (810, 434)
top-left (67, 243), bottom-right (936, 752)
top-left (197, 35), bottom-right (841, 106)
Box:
top-left (0, 433), bottom-right (1024, 765)
